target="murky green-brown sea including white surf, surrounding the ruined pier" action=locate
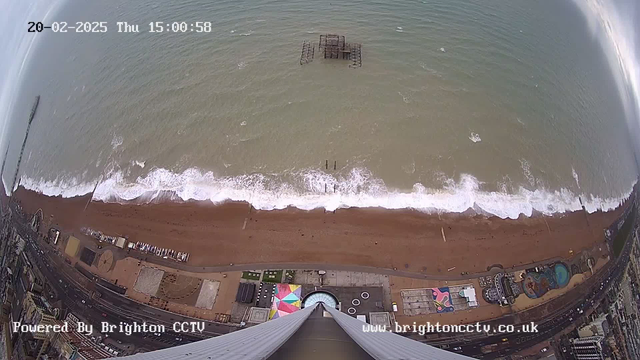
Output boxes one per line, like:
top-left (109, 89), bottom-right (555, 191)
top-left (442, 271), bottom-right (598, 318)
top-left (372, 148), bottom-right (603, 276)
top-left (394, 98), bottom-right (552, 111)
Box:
top-left (0, 0), bottom-right (638, 218)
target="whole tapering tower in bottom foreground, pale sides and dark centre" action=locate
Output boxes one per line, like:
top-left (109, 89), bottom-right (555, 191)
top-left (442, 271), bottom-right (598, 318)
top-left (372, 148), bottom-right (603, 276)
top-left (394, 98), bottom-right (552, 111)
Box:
top-left (114, 303), bottom-right (469, 360)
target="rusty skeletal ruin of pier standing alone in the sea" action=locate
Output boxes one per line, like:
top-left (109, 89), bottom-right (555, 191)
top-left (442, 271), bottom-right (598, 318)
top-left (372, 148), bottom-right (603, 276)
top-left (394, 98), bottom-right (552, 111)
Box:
top-left (300, 34), bottom-right (362, 69)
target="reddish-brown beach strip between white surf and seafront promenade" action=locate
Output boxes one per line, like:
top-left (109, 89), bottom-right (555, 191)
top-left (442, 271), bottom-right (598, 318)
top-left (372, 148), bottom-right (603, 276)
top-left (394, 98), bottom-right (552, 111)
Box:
top-left (15, 188), bottom-right (629, 277)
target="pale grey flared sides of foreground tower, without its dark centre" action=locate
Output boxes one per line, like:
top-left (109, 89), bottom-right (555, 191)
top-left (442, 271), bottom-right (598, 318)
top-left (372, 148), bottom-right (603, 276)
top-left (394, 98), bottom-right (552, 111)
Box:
top-left (112, 303), bottom-right (470, 360)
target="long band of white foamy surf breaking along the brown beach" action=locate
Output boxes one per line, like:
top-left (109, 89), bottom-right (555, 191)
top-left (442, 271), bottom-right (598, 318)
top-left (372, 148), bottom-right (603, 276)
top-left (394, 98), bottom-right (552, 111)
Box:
top-left (17, 168), bottom-right (631, 219)
